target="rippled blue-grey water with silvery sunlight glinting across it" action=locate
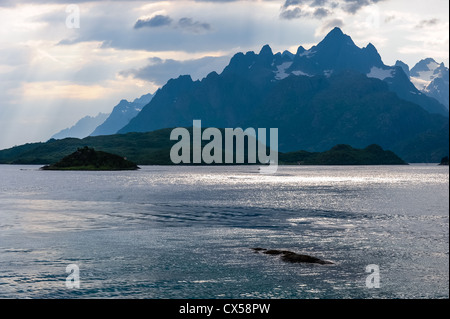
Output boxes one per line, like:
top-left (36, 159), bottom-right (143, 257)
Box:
top-left (0, 165), bottom-right (449, 299)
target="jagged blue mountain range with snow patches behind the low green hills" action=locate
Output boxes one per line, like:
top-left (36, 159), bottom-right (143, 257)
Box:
top-left (13, 28), bottom-right (449, 162)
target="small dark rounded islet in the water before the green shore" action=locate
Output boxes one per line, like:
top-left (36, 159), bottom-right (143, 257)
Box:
top-left (41, 146), bottom-right (139, 171)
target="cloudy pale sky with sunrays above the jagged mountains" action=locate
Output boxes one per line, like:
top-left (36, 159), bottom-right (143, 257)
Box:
top-left (0, 0), bottom-right (449, 149)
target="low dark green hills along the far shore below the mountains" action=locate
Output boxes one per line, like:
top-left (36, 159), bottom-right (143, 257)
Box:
top-left (0, 130), bottom-right (408, 167)
